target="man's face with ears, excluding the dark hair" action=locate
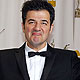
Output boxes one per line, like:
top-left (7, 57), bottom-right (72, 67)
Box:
top-left (23, 10), bottom-right (53, 48)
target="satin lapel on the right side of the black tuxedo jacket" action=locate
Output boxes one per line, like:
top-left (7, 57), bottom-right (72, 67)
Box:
top-left (41, 46), bottom-right (55, 80)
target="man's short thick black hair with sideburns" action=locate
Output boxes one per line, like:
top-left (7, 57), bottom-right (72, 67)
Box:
top-left (22, 0), bottom-right (55, 25)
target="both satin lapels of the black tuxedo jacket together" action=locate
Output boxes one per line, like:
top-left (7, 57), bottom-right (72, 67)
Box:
top-left (15, 44), bottom-right (55, 80)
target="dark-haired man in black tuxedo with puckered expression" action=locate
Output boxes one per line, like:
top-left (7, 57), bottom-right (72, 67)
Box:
top-left (0, 0), bottom-right (80, 80)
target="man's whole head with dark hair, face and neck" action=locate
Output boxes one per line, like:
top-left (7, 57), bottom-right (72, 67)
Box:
top-left (22, 0), bottom-right (54, 51)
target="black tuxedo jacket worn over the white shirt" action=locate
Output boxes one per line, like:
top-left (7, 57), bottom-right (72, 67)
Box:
top-left (0, 44), bottom-right (80, 80)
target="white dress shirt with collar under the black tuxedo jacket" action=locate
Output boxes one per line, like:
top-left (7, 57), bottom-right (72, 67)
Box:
top-left (25, 44), bottom-right (47, 80)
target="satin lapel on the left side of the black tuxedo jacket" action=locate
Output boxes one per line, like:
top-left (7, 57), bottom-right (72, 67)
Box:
top-left (15, 43), bottom-right (30, 80)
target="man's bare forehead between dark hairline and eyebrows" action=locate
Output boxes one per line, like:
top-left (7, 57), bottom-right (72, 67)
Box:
top-left (26, 10), bottom-right (50, 19)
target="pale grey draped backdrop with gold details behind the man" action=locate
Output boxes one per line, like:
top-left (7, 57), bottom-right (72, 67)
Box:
top-left (0, 0), bottom-right (80, 51)
